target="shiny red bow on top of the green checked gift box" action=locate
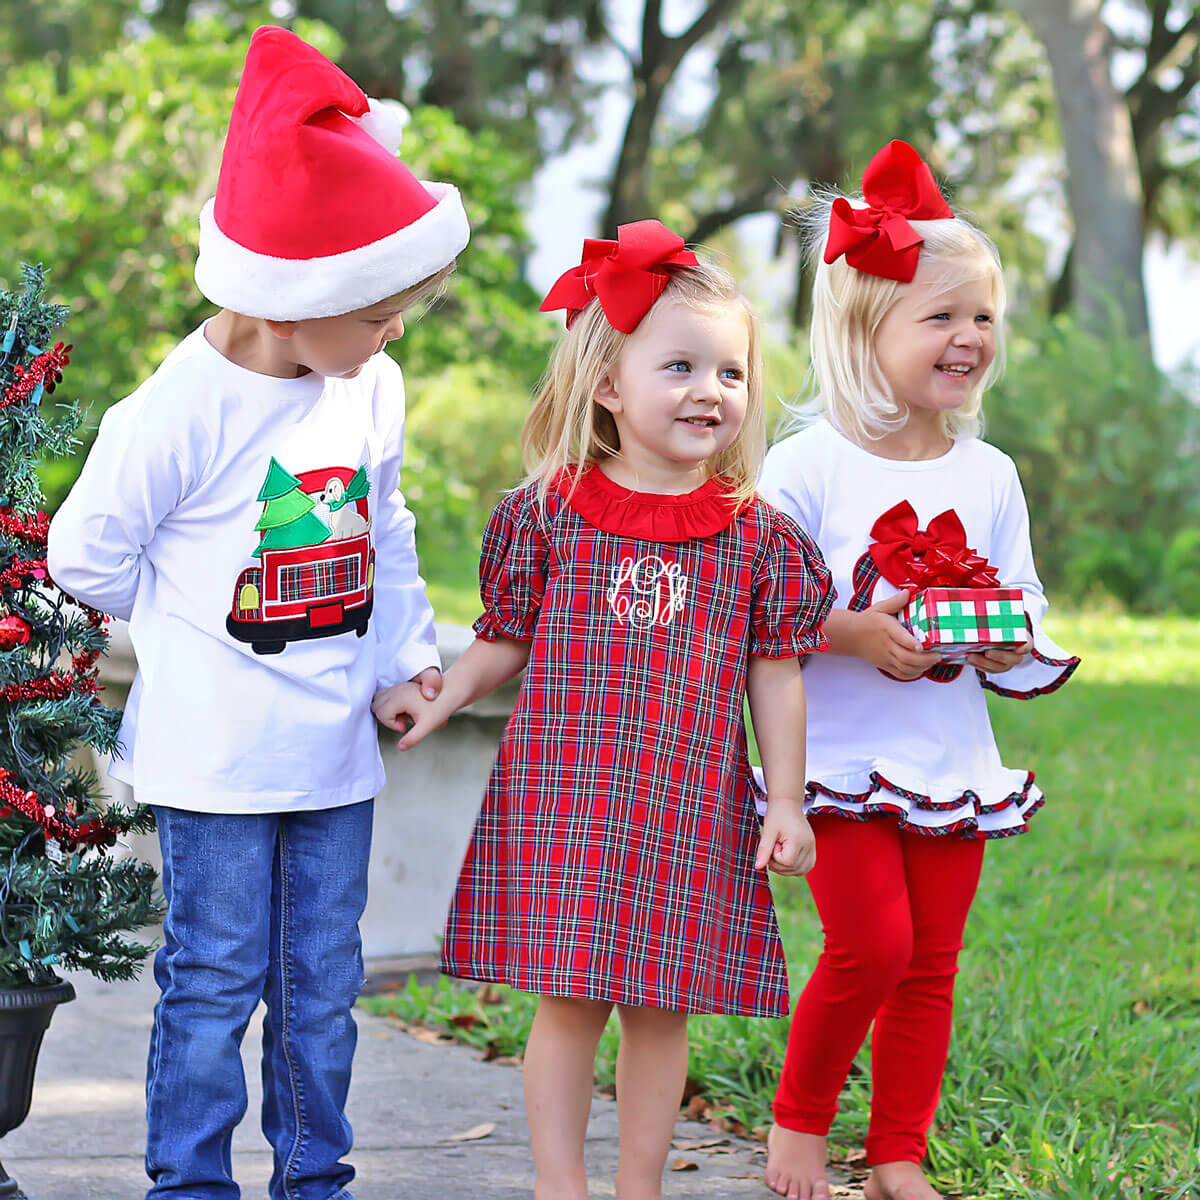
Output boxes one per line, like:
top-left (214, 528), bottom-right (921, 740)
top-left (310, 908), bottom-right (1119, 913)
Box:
top-left (869, 500), bottom-right (1000, 592)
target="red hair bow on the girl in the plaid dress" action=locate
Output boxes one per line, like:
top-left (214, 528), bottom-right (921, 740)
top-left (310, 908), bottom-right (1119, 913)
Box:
top-left (541, 220), bottom-right (700, 334)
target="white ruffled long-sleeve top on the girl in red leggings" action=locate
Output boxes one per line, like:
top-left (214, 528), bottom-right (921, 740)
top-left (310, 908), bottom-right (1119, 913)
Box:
top-left (760, 420), bottom-right (1079, 838)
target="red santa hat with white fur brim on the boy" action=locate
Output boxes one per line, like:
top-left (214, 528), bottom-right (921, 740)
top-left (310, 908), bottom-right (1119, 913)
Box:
top-left (196, 25), bottom-right (470, 320)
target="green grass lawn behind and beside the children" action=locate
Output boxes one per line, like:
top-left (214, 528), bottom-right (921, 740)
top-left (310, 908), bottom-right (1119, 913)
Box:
top-left (368, 614), bottom-right (1200, 1200)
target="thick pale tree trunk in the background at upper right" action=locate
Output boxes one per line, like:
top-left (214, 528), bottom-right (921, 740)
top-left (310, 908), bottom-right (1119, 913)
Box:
top-left (1013, 0), bottom-right (1150, 336)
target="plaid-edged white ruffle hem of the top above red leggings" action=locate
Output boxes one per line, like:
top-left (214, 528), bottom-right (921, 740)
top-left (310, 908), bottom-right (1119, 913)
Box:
top-left (805, 770), bottom-right (1045, 840)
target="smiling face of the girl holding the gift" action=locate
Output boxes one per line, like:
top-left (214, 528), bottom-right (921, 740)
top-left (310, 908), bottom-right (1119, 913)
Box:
top-left (875, 259), bottom-right (996, 418)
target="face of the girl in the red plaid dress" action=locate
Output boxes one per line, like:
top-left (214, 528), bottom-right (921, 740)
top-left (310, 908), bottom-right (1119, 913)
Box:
top-left (595, 296), bottom-right (750, 491)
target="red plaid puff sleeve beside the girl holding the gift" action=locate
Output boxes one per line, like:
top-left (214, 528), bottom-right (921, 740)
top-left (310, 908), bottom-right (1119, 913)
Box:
top-left (750, 500), bottom-right (835, 659)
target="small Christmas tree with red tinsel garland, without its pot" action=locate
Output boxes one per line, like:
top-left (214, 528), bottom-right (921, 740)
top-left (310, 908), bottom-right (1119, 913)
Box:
top-left (0, 266), bottom-right (160, 989)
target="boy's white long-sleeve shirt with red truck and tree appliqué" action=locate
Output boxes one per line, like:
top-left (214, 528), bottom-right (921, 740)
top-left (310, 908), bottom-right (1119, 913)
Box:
top-left (48, 326), bottom-right (438, 812)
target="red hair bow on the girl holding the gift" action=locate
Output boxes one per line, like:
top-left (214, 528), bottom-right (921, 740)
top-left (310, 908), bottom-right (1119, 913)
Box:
top-left (824, 142), bottom-right (954, 283)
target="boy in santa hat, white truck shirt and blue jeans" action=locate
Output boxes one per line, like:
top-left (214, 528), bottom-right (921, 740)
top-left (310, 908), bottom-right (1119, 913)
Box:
top-left (49, 28), bottom-right (469, 1200)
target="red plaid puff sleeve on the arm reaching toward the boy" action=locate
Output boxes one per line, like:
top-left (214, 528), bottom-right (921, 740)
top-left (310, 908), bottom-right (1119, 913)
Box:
top-left (474, 487), bottom-right (548, 642)
